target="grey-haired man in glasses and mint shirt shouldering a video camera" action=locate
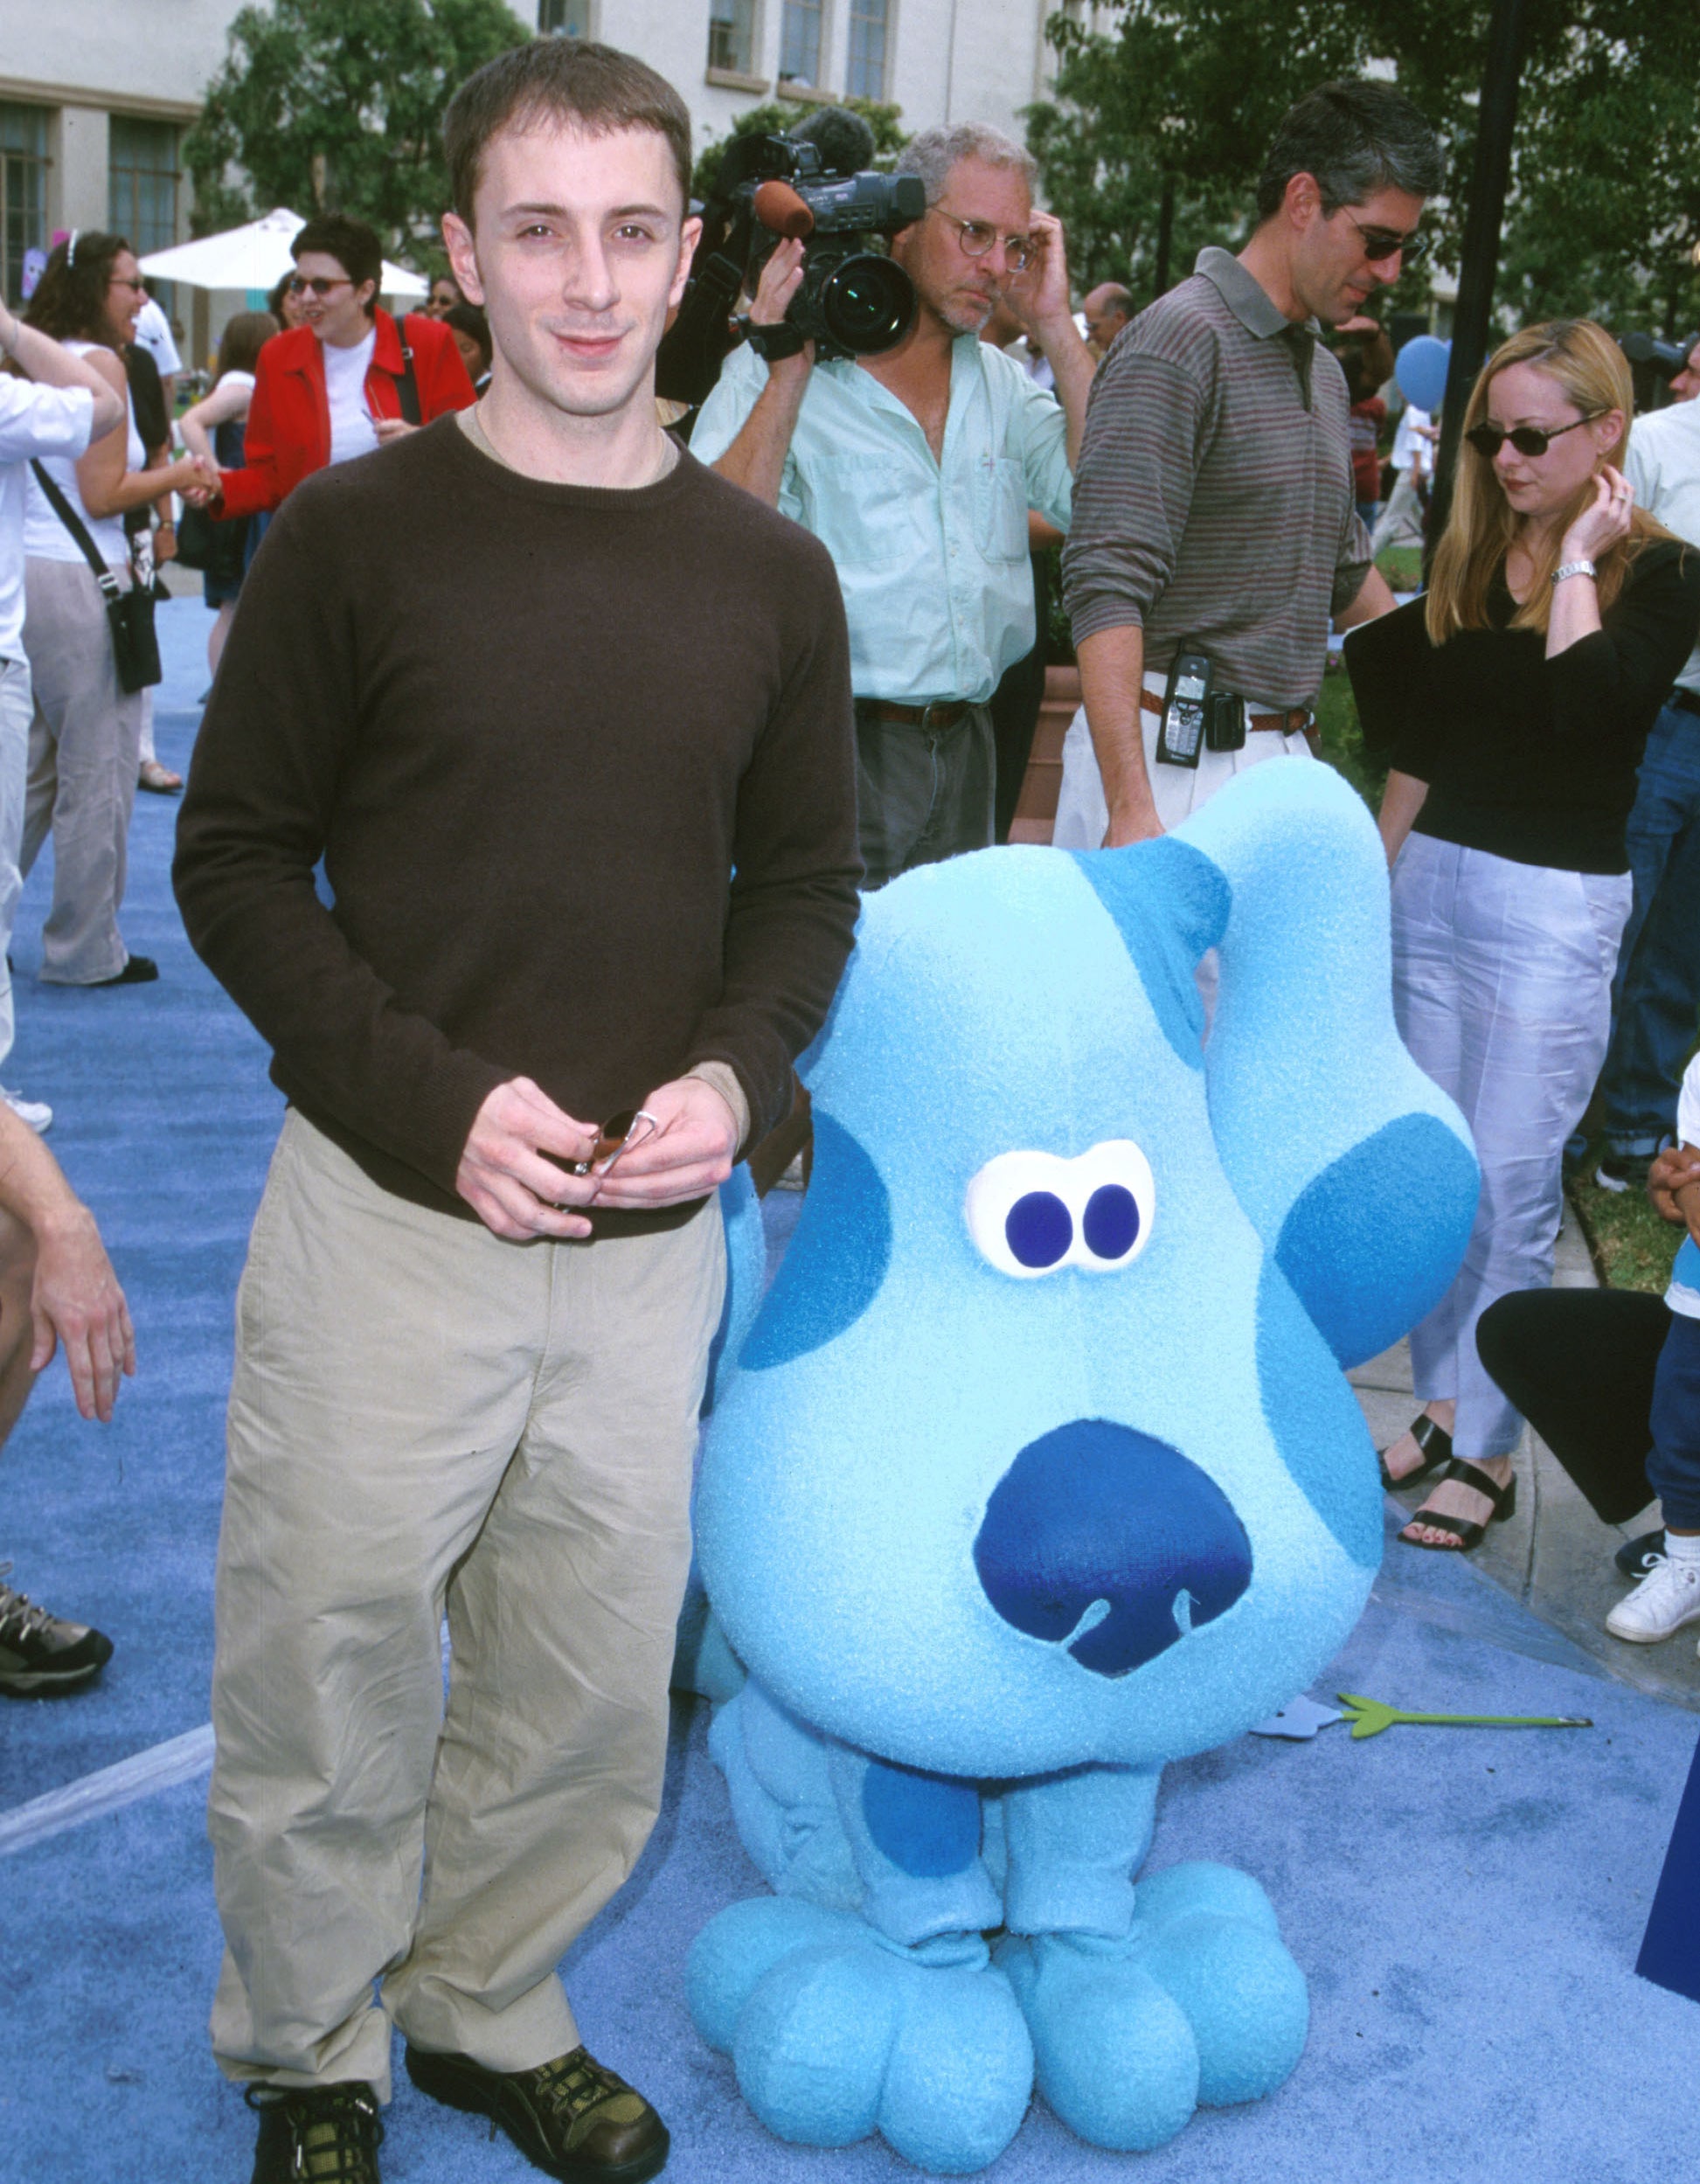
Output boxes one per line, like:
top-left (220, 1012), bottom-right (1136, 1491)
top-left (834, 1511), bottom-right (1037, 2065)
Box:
top-left (690, 122), bottom-right (1093, 887)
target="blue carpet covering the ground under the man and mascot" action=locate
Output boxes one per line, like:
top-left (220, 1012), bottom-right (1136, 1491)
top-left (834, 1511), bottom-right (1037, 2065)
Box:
top-left (0, 600), bottom-right (1700, 2184)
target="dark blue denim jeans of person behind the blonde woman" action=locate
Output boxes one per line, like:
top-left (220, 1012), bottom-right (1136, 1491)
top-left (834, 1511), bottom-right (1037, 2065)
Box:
top-left (1599, 705), bottom-right (1700, 1153)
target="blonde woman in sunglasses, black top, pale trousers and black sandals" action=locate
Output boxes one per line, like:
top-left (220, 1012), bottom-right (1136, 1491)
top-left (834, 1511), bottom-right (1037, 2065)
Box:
top-left (1346, 319), bottom-right (1700, 1549)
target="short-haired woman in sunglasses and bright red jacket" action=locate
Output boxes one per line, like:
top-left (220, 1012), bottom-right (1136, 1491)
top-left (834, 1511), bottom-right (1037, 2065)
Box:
top-left (212, 211), bottom-right (475, 517)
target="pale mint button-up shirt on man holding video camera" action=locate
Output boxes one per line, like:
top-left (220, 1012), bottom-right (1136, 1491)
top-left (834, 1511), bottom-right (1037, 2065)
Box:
top-left (690, 334), bottom-right (1069, 705)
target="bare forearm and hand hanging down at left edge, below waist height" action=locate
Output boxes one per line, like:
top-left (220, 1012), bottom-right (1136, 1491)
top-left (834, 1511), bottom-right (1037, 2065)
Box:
top-left (0, 1105), bottom-right (135, 1419)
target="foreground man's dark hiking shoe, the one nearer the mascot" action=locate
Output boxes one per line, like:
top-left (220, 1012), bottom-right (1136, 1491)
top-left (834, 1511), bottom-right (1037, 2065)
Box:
top-left (406, 2047), bottom-right (669, 2184)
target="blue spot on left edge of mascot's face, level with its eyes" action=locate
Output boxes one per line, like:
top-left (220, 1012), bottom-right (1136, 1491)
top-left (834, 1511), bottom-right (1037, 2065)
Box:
top-left (739, 1105), bottom-right (892, 1371)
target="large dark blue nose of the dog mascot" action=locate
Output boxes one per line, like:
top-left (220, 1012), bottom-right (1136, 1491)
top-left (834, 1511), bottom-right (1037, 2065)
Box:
top-left (975, 1418), bottom-right (1252, 1675)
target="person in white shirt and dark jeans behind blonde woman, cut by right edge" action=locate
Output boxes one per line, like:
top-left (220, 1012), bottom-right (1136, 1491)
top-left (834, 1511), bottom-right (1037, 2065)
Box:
top-left (1595, 341), bottom-right (1700, 1190)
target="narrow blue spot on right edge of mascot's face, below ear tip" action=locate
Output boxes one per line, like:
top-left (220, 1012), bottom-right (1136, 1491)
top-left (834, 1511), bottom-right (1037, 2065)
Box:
top-left (1257, 1266), bottom-right (1381, 1570)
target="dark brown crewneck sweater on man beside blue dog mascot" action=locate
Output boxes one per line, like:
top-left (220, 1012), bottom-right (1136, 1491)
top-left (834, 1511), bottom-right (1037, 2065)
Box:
top-left (173, 417), bottom-right (859, 1230)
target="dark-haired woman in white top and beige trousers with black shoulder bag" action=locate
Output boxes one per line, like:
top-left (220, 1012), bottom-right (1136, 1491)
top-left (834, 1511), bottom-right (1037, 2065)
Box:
top-left (20, 229), bottom-right (205, 985)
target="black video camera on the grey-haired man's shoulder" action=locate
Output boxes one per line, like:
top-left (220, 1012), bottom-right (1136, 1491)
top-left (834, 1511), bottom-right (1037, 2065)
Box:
top-left (656, 107), bottom-right (926, 406)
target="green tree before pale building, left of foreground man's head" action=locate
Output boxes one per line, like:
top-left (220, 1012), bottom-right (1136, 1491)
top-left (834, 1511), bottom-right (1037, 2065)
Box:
top-left (184, 0), bottom-right (531, 264)
